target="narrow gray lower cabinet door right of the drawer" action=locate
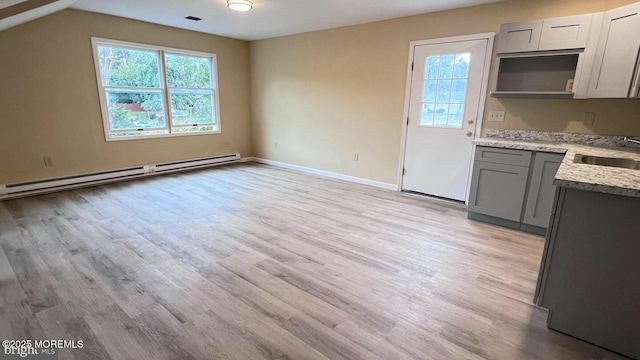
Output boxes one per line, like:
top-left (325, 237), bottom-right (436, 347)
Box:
top-left (522, 153), bottom-right (564, 228)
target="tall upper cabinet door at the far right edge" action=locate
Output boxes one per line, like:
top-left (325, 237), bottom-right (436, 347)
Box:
top-left (588, 3), bottom-right (640, 98)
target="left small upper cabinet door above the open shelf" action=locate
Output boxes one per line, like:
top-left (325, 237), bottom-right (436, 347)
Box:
top-left (498, 20), bottom-right (542, 54)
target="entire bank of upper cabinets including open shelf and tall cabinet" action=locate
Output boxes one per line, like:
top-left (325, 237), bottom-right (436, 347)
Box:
top-left (491, 3), bottom-right (640, 99)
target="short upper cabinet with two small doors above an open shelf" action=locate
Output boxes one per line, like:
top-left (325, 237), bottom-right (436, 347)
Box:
top-left (491, 13), bottom-right (602, 99)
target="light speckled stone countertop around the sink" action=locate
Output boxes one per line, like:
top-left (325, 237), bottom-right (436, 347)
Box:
top-left (474, 137), bottom-right (640, 198)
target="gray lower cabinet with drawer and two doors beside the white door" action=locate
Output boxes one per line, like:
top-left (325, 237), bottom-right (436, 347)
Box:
top-left (468, 146), bottom-right (564, 234)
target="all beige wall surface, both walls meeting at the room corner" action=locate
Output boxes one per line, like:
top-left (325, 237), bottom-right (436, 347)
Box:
top-left (5, 0), bottom-right (640, 184)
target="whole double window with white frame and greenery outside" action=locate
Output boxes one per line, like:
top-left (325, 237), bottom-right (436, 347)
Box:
top-left (92, 38), bottom-right (220, 141)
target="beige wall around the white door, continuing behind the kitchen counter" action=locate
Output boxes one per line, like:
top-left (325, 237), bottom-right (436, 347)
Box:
top-left (251, 0), bottom-right (640, 183)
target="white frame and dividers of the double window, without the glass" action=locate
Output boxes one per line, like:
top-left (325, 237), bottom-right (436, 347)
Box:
top-left (91, 37), bottom-right (222, 142)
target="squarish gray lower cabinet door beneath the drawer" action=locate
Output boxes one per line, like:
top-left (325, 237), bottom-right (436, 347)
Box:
top-left (468, 161), bottom-right (529, 222)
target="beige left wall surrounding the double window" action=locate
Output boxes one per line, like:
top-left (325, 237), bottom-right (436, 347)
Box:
top-left (0, 10), bottom-right (251, 184)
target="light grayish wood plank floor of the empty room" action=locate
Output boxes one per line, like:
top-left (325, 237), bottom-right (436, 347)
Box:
top-left (0, 164), bottom-right (632, 360)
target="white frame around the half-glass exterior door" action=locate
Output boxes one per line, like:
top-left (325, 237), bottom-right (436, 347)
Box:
top-left (398, 33), bottom-right (496, 204)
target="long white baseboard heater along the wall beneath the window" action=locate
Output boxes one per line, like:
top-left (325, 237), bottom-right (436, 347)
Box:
top-left (0, 153), bottom-right (240, 200)
